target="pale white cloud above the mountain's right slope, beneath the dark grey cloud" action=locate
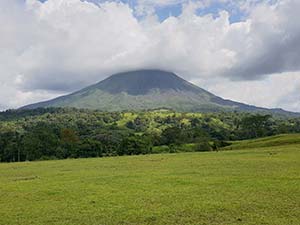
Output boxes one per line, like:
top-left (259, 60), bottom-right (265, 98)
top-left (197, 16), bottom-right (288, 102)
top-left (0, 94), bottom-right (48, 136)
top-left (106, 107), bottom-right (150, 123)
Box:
top-left (194, 72), bottom-right (300, 111)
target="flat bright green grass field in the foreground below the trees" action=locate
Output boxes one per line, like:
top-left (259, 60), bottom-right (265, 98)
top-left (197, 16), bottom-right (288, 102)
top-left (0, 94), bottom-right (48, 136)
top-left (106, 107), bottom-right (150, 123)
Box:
top-left (0, 136), bottom-right (300, 225)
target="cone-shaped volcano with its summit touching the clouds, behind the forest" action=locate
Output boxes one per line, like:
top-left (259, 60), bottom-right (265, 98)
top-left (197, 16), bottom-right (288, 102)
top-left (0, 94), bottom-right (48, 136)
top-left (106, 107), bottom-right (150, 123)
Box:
top-left (23, 70), bottom-right (292, 114)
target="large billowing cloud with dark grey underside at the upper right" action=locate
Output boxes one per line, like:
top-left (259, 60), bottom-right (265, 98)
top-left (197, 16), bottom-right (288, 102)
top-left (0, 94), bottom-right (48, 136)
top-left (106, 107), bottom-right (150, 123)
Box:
top-left (220, 0), bottom-right (300, 80)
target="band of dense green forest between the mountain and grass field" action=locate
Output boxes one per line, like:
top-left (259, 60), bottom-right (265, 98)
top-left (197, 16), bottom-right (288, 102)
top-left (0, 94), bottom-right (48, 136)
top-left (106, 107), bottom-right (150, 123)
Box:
top-left (0, 108), bottom-right (300, 162)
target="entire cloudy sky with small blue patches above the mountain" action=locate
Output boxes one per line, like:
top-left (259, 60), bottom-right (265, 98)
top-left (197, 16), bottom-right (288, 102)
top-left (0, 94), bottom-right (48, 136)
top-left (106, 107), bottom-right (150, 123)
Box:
top-left (0, 0), bottom-right (300, 112)
